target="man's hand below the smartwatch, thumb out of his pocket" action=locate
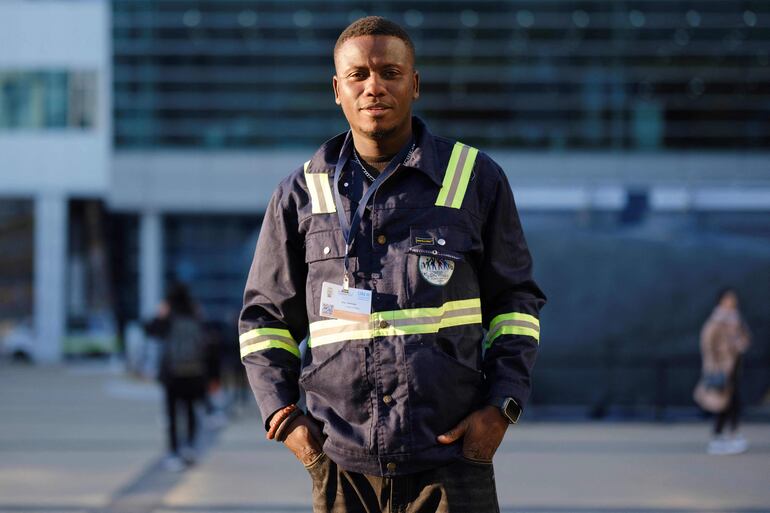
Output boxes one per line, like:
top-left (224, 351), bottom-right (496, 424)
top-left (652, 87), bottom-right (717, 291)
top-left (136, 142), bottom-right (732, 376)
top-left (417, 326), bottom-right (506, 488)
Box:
top-left (438, 406), bottom-right (509, 461)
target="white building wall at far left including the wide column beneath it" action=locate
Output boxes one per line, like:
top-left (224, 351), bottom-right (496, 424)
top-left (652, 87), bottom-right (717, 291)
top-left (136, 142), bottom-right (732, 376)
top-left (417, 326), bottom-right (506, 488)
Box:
top-left (0, 0), bottom-right (112, 362)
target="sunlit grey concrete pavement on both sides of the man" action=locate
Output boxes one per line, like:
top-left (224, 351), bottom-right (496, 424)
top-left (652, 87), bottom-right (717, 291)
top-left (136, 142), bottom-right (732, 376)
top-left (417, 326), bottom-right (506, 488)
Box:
top-left (0, 364), bottom-right (770, 513)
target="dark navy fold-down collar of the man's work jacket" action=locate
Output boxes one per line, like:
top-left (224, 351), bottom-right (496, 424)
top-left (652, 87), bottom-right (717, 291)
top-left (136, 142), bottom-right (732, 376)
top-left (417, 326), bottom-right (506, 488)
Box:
top-left (308, 116), bottom-right (444, 185)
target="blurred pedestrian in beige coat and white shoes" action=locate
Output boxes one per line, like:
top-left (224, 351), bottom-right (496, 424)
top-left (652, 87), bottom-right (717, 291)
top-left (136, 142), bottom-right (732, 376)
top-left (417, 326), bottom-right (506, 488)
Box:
top-left (694, 288), bottom-right (751, 454)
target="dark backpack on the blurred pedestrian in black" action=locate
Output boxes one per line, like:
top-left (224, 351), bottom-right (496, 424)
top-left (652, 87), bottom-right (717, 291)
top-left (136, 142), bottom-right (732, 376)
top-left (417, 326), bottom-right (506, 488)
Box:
top-left (164, 317), bottom-right (206, 378)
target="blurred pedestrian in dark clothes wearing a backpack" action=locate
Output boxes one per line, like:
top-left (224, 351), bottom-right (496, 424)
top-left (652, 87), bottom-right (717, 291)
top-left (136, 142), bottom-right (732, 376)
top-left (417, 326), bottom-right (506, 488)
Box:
top-left (145, 283), bottom-right (207, 470)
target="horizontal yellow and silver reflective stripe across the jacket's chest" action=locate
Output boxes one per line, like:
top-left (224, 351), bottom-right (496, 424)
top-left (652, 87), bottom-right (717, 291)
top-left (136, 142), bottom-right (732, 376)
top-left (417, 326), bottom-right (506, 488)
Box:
top-left (308, 298), bottom-right (481, 347)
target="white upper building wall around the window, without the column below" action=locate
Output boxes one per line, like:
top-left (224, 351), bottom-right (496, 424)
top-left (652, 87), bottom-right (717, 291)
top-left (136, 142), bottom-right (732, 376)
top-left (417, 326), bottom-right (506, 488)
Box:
top-left (0, 0), bottom-right (112, 196)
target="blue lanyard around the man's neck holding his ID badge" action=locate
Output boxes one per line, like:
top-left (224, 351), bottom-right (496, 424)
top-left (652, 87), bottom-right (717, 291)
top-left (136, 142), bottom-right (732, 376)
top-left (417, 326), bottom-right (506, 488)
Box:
top-left (334, 131), bottom-right (411, 290)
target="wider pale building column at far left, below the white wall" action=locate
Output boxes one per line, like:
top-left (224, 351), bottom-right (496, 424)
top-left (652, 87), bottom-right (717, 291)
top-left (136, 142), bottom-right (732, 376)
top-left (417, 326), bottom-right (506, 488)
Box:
top-left (33, 192), bottom-right (69, 363)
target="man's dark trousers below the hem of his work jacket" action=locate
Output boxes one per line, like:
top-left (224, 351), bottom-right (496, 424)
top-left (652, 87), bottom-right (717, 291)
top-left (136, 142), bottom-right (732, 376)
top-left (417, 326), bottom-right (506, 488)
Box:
top-left (306, 454), bottom-right (500, 513)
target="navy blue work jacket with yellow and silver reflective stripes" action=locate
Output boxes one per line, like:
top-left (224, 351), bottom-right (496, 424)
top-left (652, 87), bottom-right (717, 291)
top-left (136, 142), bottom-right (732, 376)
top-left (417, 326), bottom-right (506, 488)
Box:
top-left (240, 118), bottom-right (545, 476)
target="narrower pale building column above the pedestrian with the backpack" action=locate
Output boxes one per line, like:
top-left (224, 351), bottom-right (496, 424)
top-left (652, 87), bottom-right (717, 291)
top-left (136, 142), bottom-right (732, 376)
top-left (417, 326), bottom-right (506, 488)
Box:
top-left (139, 212), bottom-right (163, 319)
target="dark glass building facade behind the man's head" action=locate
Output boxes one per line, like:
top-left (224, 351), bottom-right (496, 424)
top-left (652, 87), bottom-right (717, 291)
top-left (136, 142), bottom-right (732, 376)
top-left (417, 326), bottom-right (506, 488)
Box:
top-left (113, 0), bottom-right (770, 150)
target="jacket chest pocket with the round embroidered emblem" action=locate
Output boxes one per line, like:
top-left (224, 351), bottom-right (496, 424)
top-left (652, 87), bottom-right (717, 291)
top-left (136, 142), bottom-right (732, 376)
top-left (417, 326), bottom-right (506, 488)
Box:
top-left (406, 226), bottom-right (478, 306)
